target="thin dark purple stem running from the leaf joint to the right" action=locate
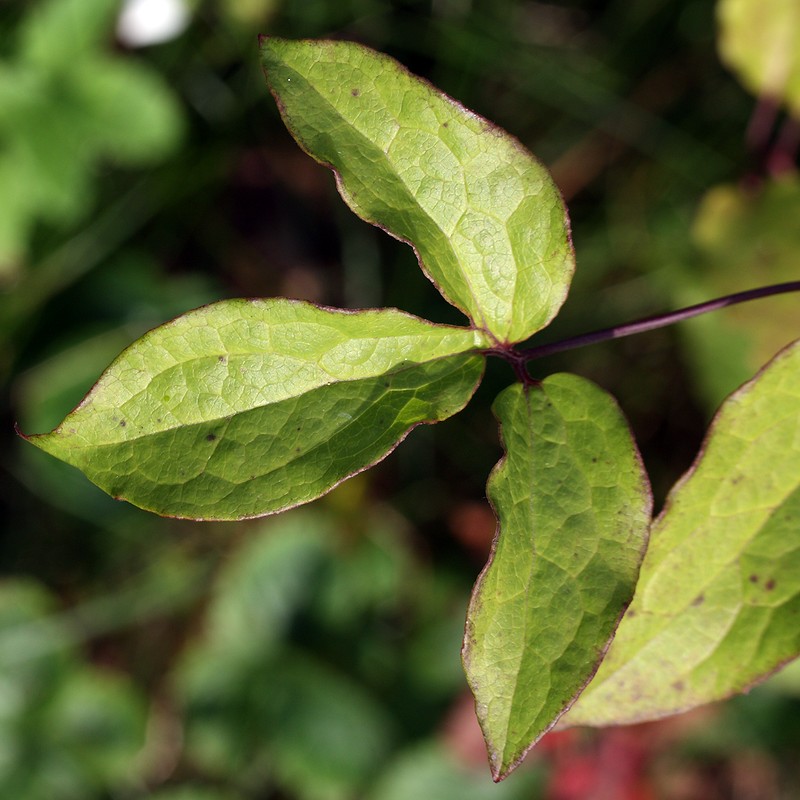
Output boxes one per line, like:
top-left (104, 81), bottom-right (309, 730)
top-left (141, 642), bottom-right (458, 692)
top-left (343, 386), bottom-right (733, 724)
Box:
top-left (518, 281), bottom-right (800, 362)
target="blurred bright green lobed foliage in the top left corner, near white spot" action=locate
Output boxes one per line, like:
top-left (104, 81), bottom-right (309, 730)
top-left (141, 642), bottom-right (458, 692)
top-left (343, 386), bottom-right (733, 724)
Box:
top-left (0, 0), bottom-right (182, 283)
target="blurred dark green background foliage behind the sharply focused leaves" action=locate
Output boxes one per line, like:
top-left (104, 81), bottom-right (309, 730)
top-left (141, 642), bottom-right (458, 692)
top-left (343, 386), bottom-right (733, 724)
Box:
top-left (0, 0), bottom-right (800, 800)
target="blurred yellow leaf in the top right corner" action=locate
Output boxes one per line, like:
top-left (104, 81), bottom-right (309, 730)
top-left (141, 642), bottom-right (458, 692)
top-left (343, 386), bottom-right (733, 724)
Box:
top-left (717, 0), bottom-right (800, 113)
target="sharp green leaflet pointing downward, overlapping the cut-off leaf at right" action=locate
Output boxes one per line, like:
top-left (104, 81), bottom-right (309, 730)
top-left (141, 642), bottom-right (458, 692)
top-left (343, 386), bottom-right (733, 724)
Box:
top-left (464, 375), bottom-right (651, 780)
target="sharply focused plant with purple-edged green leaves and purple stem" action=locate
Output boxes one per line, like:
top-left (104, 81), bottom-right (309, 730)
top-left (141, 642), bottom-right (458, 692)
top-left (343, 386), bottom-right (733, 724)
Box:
top-left (21, 37), bottom-right (800, 780)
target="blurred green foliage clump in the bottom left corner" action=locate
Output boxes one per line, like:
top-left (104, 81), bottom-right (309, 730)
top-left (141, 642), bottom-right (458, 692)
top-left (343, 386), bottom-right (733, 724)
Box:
top-left (0, 580), bottom-right (147, 800)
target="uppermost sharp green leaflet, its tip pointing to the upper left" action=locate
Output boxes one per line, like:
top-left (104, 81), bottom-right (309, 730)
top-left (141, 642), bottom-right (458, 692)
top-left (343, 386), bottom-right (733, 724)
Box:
top-left (262, 37), bottom-right (574, 342)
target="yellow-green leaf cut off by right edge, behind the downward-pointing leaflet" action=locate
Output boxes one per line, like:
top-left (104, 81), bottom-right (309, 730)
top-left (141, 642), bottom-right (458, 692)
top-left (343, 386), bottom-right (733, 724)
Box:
top-left (565, 342), bottom-right (800, 725)
